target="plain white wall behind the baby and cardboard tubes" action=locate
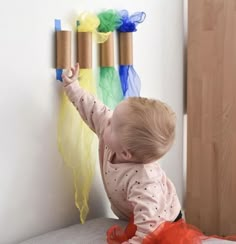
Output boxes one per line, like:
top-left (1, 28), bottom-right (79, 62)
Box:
top-left (0, 0), bottom-right (183, 244)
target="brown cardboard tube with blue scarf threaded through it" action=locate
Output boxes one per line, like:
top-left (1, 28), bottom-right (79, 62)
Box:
top-left (119, 32), bottom-right (133, 65)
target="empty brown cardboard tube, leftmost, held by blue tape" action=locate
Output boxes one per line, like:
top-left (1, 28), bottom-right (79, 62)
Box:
top-left (56, 31), bottom-right (71, 69)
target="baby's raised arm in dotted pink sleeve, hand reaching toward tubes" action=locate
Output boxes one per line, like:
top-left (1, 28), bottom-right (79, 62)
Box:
top-left (62, 63), bottom-right (112, 136)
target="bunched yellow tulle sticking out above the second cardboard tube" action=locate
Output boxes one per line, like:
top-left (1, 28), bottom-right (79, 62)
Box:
top-left (76, 12), bottom-right (111, 43)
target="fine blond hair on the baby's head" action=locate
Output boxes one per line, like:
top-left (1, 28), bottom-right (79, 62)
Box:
top-left (120, 97), bottom-right (176, 163)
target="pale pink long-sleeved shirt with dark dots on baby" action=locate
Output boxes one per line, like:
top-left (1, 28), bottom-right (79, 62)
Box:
top-left (65, 82), bottom-right (181, 244)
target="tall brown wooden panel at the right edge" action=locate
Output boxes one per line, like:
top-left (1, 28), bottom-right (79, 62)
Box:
top-left (186, 0), bottom-right (236, 235)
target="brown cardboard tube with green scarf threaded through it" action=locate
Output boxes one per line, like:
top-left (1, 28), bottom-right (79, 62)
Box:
top-left (99, 33), bottom-right (114, 67)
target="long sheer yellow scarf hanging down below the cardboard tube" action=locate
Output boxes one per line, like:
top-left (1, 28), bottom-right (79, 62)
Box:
top-left (58, 69), bottom-right (97, 223)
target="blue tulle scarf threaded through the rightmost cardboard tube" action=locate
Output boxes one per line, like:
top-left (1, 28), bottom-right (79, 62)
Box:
top-left (117, 10), bottom-right (146, 98)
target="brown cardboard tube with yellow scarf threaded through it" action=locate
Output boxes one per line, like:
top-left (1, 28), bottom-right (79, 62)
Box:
top-left (76, 32), bottom-right (92, 69)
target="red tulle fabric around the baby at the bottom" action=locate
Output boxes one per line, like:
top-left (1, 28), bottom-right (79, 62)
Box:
top-left (107, 216), bottom-right (236, 244)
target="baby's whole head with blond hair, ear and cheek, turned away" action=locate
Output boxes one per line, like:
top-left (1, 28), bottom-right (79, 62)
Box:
top-left (104, 97), bottom-right (176, 163)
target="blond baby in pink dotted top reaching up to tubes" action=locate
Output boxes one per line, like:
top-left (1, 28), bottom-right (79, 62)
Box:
top-left (62, 64), bottom-right (181, 244)
